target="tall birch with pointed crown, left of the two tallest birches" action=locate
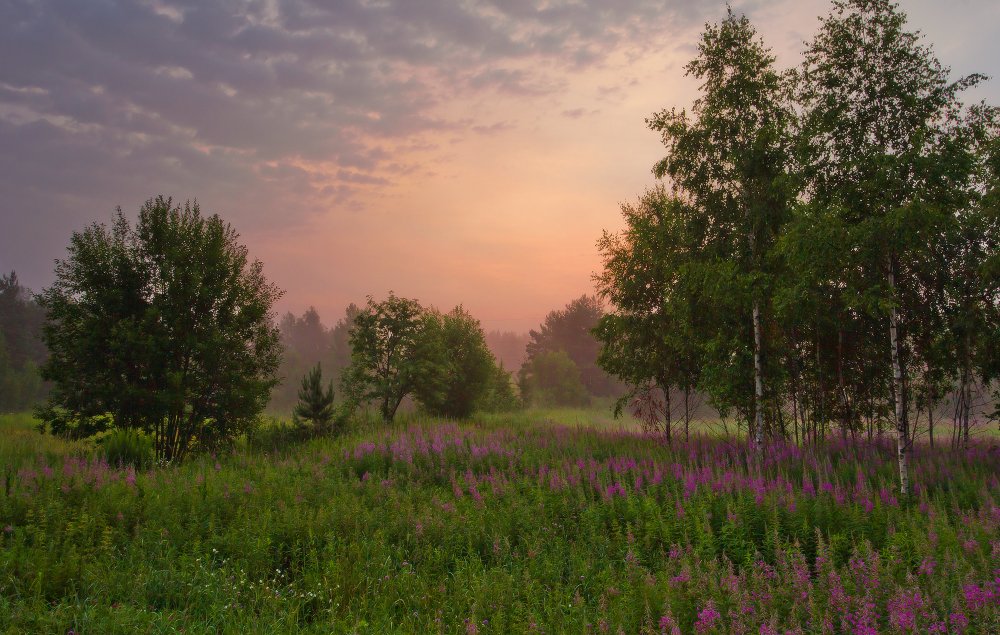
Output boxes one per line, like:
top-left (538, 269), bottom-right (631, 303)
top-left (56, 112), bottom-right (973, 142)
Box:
top-left (640, 9), bottom-right (795, 432)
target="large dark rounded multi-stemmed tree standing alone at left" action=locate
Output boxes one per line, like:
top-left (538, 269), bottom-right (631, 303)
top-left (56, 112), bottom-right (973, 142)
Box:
top-left (40, 196), bottom-right (281, 461)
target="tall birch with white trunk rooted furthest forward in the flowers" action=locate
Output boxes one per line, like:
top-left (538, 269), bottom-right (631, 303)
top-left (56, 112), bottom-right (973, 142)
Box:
top-left (797, 0), bottom-right (982, 495)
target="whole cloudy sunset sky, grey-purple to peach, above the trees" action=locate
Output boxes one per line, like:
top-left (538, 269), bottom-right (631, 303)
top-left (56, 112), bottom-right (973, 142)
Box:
top-left (0, 0), bottom-right (1000, 331)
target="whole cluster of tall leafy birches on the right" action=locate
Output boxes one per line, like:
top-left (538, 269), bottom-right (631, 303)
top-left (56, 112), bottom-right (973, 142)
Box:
top-left (595, 0), bottom-right (1000, 458)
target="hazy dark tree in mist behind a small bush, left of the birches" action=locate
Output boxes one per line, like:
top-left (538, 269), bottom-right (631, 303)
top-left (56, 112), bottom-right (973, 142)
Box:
top-left (524, 295), bottom-right (615, 396)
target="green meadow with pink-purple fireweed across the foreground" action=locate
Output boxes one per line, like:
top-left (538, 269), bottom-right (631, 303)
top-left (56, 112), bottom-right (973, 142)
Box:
top-left (0, 411), bottom-right (1000, 635)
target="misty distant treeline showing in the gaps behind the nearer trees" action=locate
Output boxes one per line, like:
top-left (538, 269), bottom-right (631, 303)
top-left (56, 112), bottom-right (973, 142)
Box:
top-left (0, 262), bottom-right (621, 415)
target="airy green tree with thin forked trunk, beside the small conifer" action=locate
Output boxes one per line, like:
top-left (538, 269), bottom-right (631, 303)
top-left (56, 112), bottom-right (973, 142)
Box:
top-left (342, 292), bottom-right (447, 422)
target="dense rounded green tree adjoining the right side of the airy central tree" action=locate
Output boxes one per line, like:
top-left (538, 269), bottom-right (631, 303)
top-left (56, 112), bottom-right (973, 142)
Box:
top-left (416, 306), bottom-right (495, 419)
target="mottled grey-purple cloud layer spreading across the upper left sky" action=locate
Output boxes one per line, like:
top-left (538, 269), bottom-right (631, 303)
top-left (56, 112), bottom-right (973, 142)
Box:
top-left (0, 0), bottom-right (752, 296)
